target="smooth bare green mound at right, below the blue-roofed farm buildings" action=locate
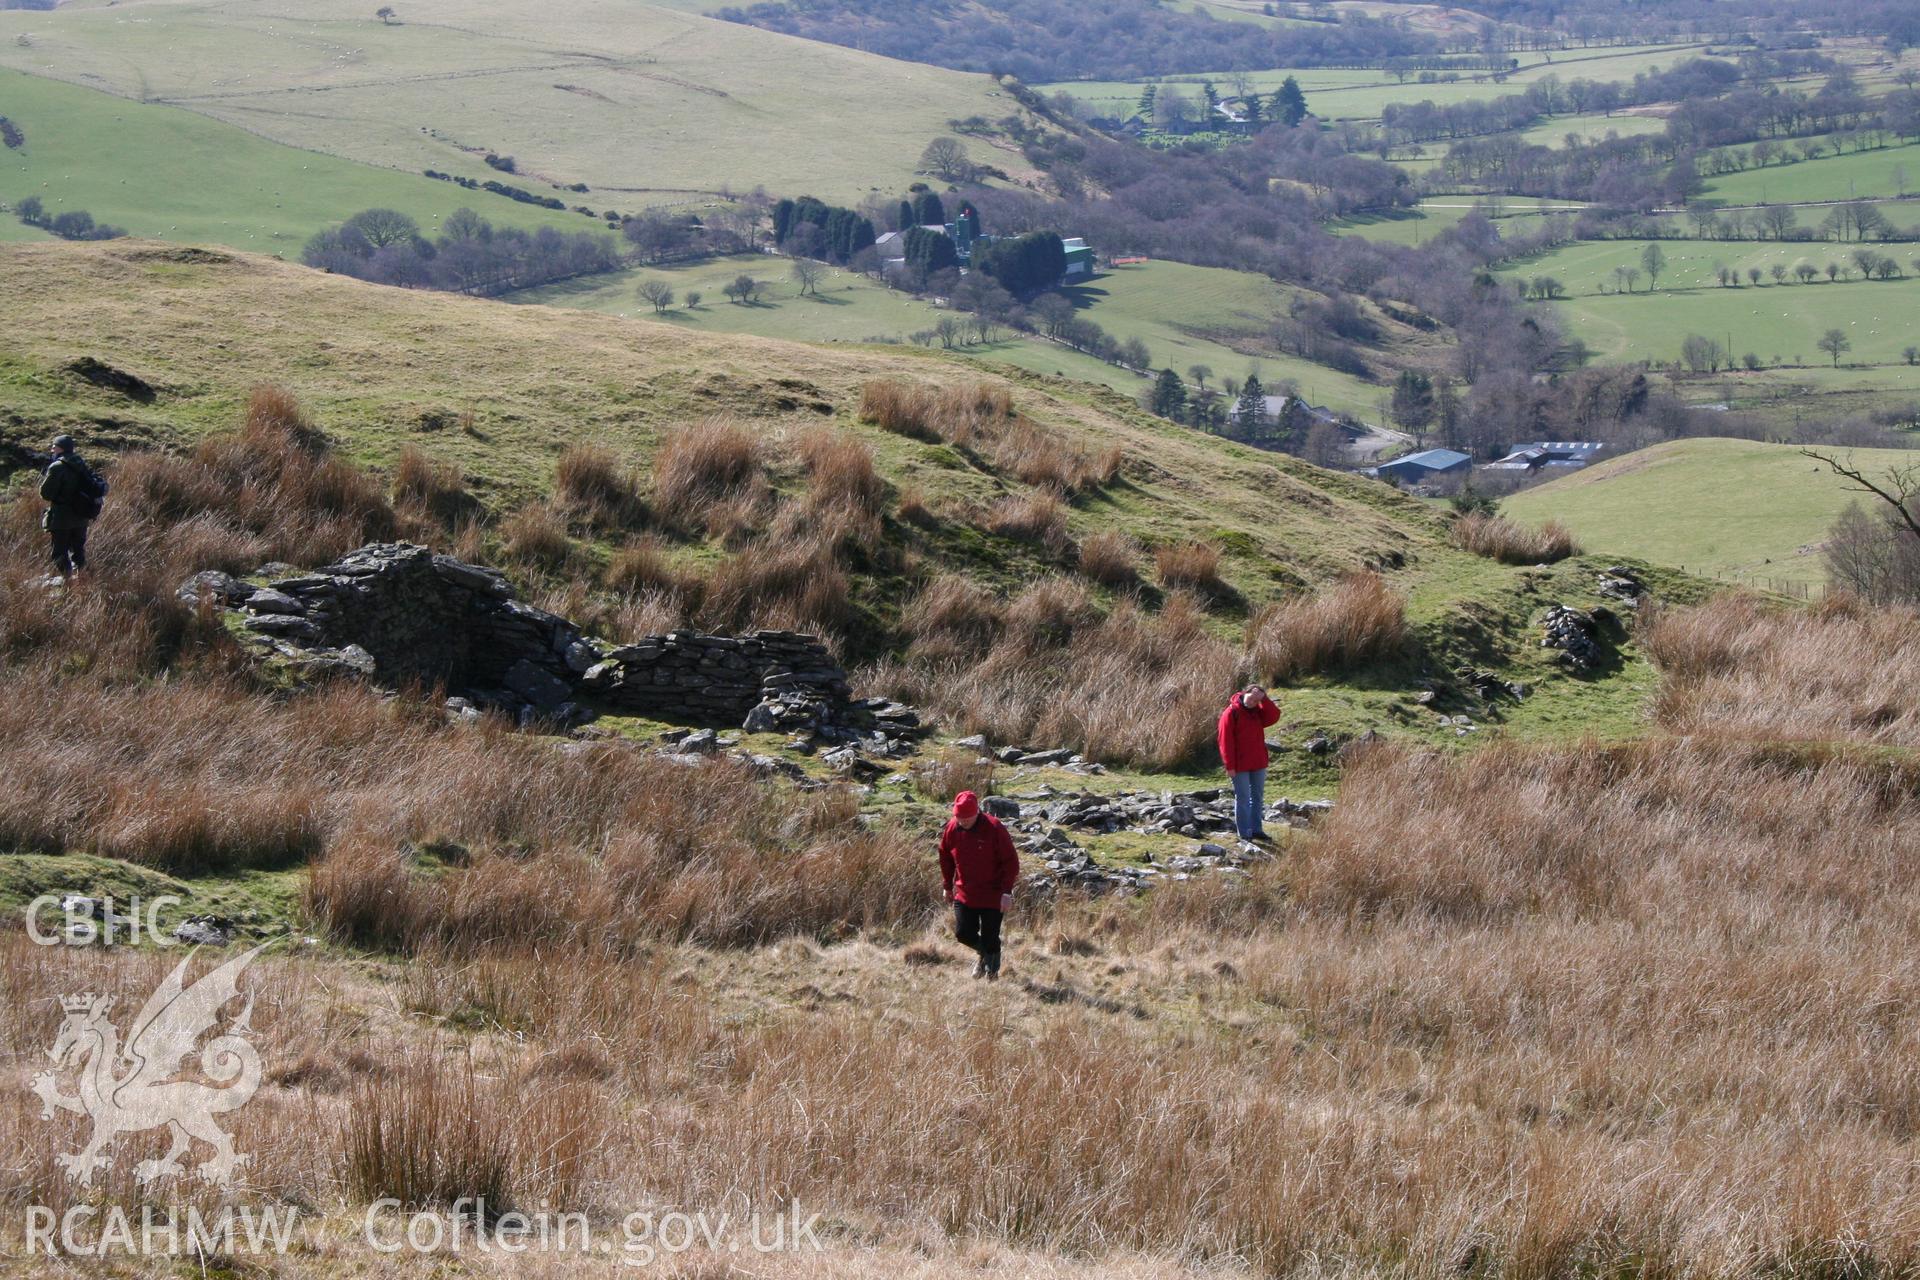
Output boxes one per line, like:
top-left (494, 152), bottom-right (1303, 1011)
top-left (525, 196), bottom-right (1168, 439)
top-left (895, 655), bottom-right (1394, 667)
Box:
top-left (1503, 439), bottom-right (1914, 583)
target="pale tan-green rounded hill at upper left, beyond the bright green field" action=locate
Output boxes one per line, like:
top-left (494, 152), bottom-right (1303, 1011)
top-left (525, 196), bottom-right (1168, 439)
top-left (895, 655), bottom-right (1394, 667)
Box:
top-left (0, 0), bottom-right (1018, 207)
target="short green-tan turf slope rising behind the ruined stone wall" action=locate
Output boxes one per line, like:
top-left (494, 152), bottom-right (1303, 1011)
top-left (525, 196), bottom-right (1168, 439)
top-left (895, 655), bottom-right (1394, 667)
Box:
top-left (0, 242), bottom-right (1684, 768)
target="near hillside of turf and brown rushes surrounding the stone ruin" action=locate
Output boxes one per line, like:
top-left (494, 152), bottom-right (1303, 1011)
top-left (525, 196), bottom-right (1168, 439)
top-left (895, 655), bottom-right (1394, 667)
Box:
top-left (11, 242), bottom-right (1920, 1280)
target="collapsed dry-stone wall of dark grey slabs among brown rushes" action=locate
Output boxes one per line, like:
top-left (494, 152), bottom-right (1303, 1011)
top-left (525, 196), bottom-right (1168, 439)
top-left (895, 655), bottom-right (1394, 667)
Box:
top-left (180, 543), bottom-right (879, 741)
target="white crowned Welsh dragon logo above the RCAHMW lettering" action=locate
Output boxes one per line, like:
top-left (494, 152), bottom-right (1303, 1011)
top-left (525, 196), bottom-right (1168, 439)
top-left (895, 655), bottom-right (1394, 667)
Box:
top-left (33, 944), bottom-right (269, 1188)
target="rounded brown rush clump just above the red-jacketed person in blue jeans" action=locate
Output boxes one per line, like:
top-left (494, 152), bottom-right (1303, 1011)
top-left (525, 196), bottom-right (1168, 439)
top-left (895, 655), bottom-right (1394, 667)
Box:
top-left (1246, 574), bottom-right (1407, 683)
